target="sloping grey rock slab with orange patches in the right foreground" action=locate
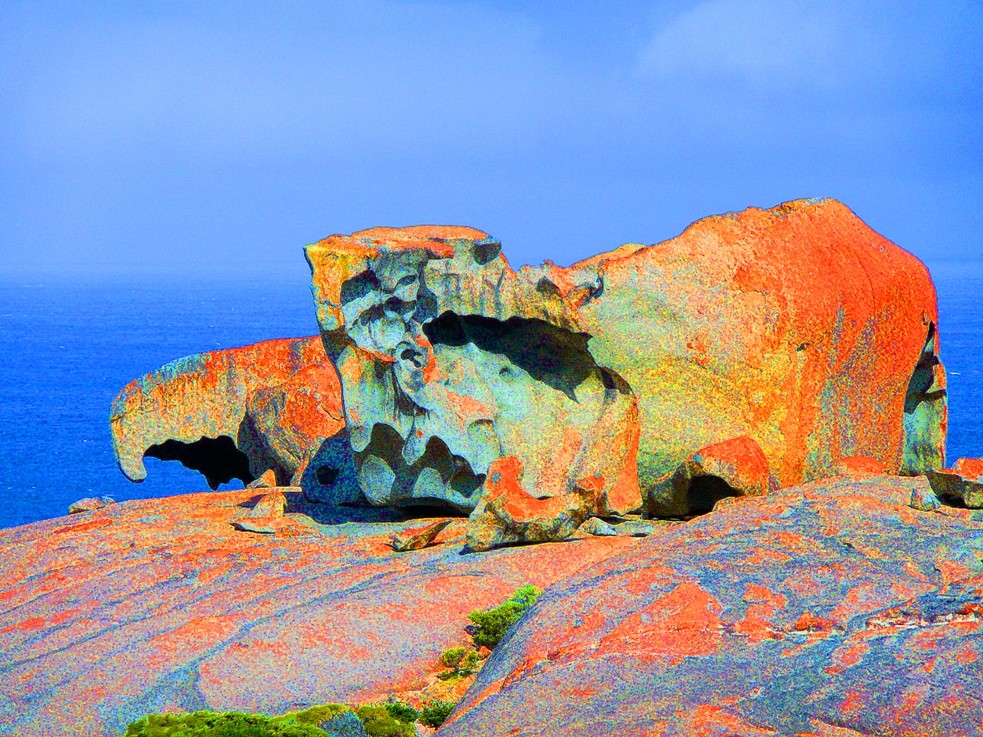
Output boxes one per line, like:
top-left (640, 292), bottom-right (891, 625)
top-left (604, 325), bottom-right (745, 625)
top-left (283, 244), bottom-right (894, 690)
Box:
top-left (439, 476), bottom-right (983, 737)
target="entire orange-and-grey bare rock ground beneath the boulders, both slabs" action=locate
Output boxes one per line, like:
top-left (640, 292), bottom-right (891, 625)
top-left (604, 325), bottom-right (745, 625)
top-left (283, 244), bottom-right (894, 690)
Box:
top-left (0, 477), bottom-right (983, 737)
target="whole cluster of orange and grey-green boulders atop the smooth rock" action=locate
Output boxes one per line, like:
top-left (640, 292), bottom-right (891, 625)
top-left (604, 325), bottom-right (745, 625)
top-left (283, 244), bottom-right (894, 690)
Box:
top-left (112, 200), bottom-right (946, 549)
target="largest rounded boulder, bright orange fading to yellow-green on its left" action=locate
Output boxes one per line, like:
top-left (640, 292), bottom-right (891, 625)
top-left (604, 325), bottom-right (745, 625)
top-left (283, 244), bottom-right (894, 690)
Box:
top-left (552, 200), bottom-right (946, 489)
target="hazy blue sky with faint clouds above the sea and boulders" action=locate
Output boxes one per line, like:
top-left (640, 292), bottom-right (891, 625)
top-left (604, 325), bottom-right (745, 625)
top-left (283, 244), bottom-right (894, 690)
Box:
top-left (0, 0), bottom-right (983, 280)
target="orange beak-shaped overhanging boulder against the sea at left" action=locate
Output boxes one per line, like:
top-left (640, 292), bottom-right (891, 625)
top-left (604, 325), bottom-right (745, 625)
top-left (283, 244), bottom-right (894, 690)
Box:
top-left (110, 338), bottom-right (344, 489)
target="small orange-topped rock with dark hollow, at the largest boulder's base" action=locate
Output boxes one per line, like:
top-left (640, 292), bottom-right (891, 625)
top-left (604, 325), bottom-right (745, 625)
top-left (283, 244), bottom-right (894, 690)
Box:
top-left (645, 435), bottom-right (778, 517)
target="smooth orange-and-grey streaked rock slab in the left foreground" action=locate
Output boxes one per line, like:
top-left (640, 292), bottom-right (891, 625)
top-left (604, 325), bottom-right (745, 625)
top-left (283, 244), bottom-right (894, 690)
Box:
top-left (0, 489), bottom-right (634, 737)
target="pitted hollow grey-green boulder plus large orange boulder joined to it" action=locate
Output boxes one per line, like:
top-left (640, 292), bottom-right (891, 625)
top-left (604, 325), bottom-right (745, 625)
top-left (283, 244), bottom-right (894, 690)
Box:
top-left (306, 200), bottom-right (946, 531)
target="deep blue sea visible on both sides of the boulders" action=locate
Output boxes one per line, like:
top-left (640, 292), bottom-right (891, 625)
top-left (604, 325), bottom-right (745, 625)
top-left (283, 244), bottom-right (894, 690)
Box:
top-left (0, 261), bottom-right (983, 528)
